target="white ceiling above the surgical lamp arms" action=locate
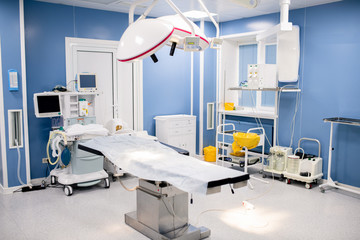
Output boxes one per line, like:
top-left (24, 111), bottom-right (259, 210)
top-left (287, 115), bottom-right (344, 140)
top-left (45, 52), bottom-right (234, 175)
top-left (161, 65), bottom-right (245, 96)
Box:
top-left (37, 0), bottom-right (341, 22)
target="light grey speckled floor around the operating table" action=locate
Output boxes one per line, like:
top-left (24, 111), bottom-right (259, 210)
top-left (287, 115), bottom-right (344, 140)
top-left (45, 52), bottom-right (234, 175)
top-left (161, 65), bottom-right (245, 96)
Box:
top-left (0, 169), bottom-right (360, 240)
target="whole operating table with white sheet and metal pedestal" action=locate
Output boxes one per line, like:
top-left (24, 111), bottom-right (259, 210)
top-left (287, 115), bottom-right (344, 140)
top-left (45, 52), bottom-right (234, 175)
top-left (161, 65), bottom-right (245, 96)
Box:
top-left (78, 135), bottom-right (249, 240)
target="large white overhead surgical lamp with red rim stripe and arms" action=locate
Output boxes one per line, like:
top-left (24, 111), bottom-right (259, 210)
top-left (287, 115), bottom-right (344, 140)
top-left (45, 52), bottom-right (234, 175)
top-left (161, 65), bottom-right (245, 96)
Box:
top-left (117, 0), bottom-right (218, 62)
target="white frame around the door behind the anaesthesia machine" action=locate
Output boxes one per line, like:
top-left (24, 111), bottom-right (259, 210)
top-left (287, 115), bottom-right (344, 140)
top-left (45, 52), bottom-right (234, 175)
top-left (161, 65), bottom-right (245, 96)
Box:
top-left (65, 37), bottom-right (143, 131)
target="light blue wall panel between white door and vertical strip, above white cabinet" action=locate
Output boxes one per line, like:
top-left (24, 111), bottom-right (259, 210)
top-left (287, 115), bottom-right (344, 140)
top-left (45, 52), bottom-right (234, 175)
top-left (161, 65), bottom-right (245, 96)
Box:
top-left (143, 47), bottom-right (191, 135)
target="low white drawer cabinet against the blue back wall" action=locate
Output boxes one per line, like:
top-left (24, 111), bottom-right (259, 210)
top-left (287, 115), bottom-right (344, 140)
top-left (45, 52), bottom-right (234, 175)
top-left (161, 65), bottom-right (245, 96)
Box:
top-left (154, 115), bottom-right (196, 156)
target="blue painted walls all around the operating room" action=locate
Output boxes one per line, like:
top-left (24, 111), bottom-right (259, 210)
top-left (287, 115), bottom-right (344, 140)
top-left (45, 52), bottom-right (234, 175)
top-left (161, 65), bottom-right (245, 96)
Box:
top-left (7, 0), bottom-right (360, 186)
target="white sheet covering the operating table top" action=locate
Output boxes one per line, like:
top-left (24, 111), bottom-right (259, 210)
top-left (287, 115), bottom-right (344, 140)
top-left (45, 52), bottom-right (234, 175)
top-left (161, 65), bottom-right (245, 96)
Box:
top-left (82, 135), bottom-right (248, 194)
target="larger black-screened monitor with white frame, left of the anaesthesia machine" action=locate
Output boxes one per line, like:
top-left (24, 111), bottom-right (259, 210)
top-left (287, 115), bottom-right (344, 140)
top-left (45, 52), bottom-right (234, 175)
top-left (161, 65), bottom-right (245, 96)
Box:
top-left (34, 94), bottom-right (61, 118)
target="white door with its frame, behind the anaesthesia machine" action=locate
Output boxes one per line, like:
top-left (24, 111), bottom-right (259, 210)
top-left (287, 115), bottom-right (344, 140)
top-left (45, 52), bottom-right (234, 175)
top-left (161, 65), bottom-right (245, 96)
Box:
top-left (66, 38), bottom-right (137, 128)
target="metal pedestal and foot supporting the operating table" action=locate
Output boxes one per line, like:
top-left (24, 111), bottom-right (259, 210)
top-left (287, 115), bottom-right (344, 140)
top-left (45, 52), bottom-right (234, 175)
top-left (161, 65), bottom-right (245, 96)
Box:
top-left (125, 179), bottom-right (210, 240)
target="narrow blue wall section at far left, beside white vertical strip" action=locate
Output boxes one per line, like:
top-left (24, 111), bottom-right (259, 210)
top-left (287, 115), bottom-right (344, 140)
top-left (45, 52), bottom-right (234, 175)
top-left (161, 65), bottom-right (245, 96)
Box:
top-left (0, 0), bottom-right (26, 187)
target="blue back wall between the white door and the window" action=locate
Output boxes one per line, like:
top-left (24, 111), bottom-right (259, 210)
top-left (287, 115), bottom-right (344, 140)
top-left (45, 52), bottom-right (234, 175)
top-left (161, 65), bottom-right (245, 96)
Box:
top-left (143, 22), bottom-right (216, 156)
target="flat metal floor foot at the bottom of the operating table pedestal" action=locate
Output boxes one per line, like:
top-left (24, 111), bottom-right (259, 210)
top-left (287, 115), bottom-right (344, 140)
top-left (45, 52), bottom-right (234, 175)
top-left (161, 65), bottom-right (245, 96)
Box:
top-left (125, 211), bottom-right (210, 240)
